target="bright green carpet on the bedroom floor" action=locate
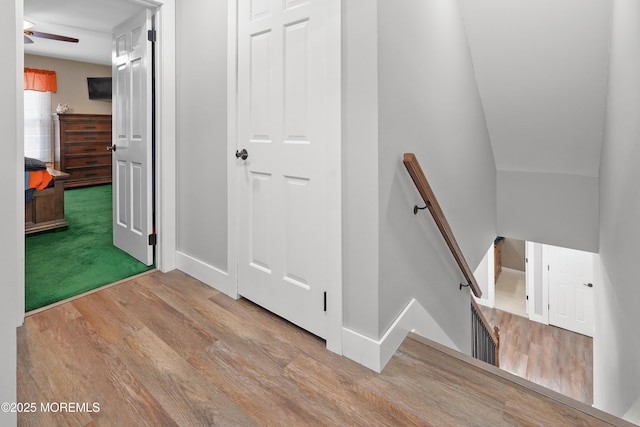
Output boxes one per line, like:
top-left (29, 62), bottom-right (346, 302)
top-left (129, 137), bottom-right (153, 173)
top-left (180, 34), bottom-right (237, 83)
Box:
top-left (25, 185), bottom-right (152, 311)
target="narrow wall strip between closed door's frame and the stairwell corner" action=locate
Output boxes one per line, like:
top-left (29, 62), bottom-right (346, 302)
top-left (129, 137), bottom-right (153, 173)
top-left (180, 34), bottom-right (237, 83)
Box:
top-left (342, 0), bottom-right (379, 338)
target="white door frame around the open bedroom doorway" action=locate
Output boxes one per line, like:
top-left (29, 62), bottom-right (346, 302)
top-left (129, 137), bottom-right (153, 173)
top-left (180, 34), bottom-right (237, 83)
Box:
top-left (14, 0), bottom-right (176, 325)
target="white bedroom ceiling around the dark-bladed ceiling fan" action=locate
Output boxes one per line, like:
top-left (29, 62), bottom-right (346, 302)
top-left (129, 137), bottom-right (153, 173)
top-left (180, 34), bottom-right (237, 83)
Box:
top-left (24, 0), bottom-right (144, 64)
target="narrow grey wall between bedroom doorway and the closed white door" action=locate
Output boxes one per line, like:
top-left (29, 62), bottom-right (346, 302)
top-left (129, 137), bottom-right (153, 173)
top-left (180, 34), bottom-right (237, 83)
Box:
top-left (176, 0), bottom-right (229, 290)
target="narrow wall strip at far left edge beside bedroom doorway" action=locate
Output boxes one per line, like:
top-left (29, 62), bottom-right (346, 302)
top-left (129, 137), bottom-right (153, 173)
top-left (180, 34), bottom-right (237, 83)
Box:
top-left (0, 0), bottom-right (24, 426)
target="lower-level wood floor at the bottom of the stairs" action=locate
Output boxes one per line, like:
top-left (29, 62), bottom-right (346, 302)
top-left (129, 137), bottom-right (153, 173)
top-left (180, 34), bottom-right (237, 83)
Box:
top-left (480, 306), bottom-right (593, 405)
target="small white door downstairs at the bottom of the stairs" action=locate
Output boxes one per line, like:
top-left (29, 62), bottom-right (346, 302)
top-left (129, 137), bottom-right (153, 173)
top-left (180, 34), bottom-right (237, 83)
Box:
top-left (547, 246), bottom-right (594, 337)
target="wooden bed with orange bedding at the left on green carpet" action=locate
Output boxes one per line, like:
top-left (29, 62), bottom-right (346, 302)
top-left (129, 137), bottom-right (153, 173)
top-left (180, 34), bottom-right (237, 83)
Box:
top-left (24, 158), bottom-right (69, 234)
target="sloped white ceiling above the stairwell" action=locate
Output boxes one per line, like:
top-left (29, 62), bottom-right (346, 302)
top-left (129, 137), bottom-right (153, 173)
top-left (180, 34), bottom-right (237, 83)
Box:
top-left (459, 0), bottom-right (612, 177)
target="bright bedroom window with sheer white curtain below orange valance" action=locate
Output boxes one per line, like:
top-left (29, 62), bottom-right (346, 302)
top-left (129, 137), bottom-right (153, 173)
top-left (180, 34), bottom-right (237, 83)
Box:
top-left (24, 90), bottom-right (53, 162)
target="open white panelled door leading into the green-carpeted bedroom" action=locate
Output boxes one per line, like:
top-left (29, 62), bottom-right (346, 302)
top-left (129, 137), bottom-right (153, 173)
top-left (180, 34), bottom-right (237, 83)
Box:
top-left (112, 10), bottom-right (153, 265)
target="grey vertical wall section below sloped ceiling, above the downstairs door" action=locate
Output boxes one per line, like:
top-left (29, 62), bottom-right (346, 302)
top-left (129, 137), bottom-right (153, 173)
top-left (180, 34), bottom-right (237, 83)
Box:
top-left (498, 171), bottom-right (599, 252)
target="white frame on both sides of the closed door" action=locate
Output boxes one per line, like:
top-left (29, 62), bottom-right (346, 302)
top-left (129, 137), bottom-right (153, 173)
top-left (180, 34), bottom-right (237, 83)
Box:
top-left (227, 0), bottom-right (343, 354)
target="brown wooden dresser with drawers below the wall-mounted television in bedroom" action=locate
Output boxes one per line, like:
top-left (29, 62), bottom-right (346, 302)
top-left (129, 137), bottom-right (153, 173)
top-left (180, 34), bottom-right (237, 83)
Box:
top-left (53, 114), bottom-right (111, 188)
